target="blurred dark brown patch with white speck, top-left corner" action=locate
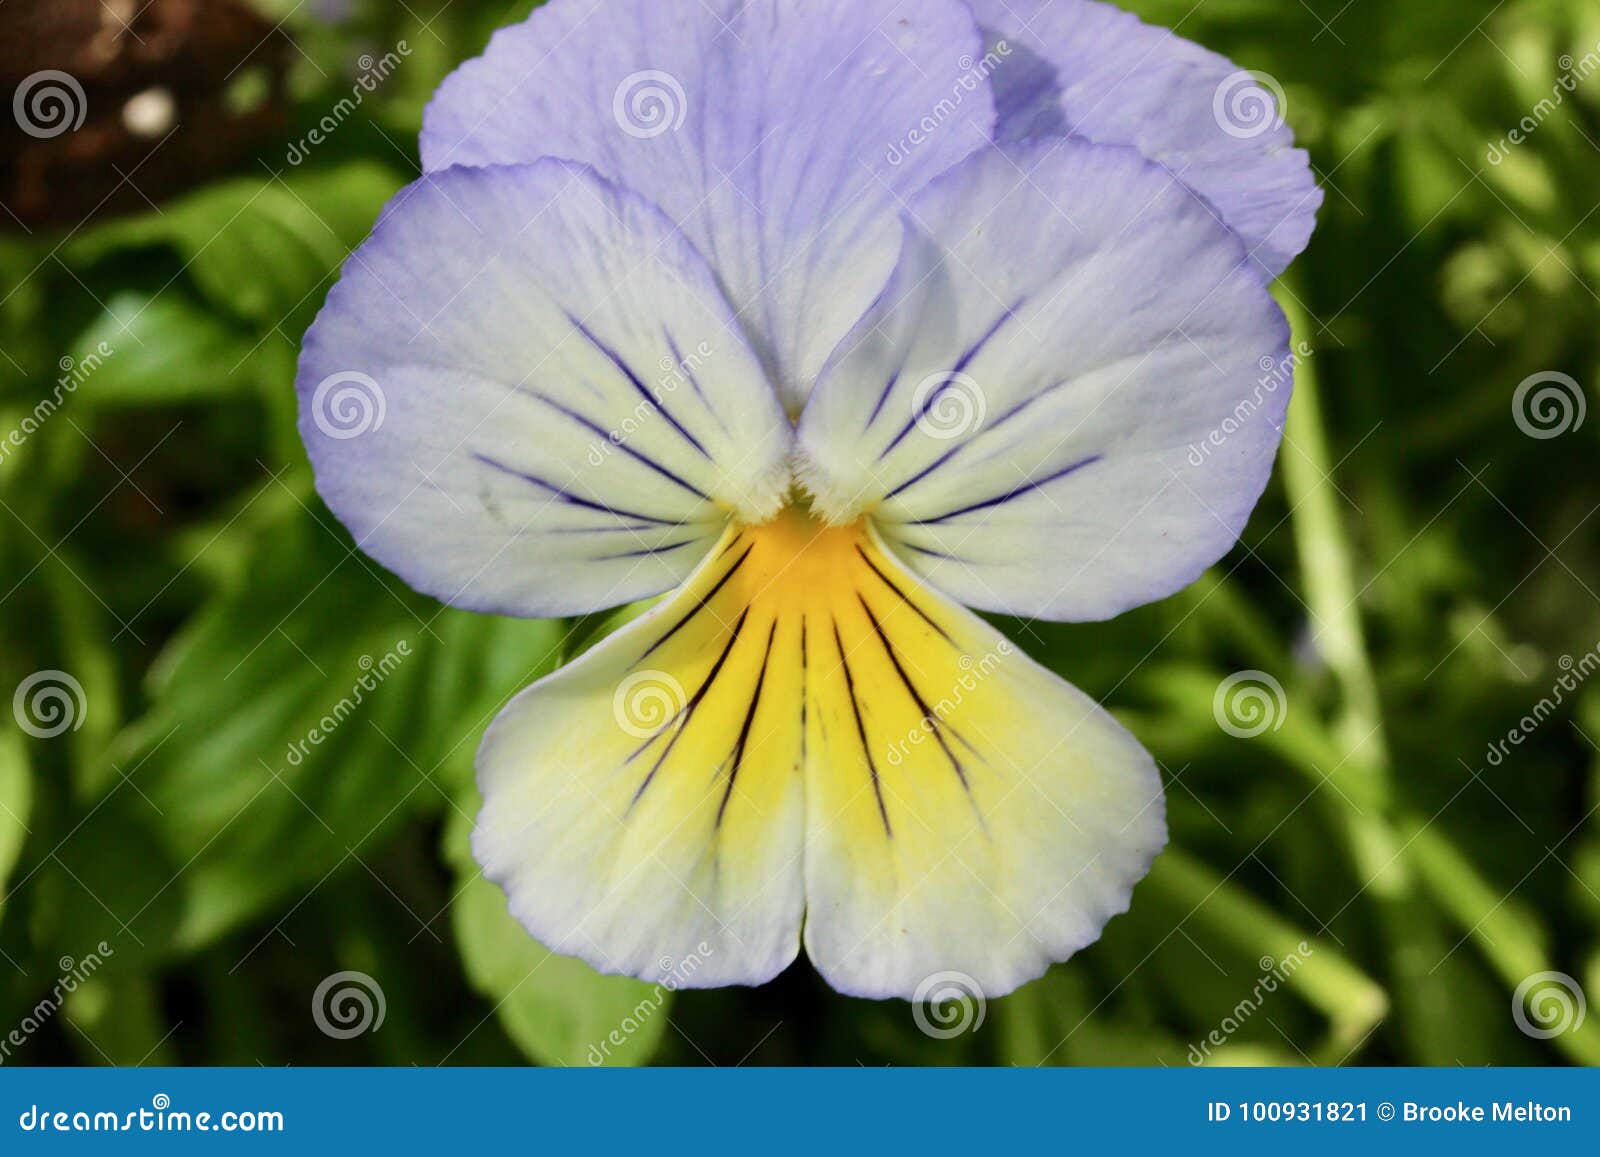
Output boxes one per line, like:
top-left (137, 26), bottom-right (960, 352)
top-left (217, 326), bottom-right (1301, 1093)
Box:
top-left (0, 0), bottom-right (290, 232)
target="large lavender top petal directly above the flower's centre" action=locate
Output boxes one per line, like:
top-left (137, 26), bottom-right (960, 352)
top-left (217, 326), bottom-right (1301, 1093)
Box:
top-left (422, 0), bottom-right (994, 408)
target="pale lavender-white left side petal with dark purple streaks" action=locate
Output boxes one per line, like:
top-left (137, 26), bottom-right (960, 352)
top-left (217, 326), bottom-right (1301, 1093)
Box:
top-left (298, 160), bottom-right (792, 616)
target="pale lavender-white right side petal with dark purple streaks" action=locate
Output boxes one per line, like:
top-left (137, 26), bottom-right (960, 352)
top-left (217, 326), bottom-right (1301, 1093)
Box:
top-left (800, 138), bottom-right (1290, 619)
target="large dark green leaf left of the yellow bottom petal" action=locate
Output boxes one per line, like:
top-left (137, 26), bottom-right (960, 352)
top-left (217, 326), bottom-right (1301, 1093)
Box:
top-left (104, 504), bottom-right (555, 949)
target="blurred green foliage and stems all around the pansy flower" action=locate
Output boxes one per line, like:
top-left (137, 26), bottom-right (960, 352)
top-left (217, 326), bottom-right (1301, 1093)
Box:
top-left (0, 0), bottom-right (1600, 1066)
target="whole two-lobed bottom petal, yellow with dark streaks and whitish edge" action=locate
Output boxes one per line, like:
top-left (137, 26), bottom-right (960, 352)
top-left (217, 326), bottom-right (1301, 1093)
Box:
top-left (475, 509), bottom-right (1165, 995)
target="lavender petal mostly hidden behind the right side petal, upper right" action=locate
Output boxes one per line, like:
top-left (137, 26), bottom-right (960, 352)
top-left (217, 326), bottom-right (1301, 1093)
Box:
top-left (971, 0), bottom-right (1322, 277)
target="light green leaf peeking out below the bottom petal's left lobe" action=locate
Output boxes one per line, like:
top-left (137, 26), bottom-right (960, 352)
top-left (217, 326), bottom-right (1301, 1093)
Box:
top-left (446, 806), bottom-right (672, 1066)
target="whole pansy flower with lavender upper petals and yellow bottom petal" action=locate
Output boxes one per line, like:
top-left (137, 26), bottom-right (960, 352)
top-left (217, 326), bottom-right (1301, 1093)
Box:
top-left (299, 0), bottom-right (1320, 997)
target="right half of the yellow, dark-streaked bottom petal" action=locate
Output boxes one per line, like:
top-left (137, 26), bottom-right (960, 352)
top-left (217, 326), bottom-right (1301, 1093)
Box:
top-left (805, 531), bottom-right (1166, 997)
